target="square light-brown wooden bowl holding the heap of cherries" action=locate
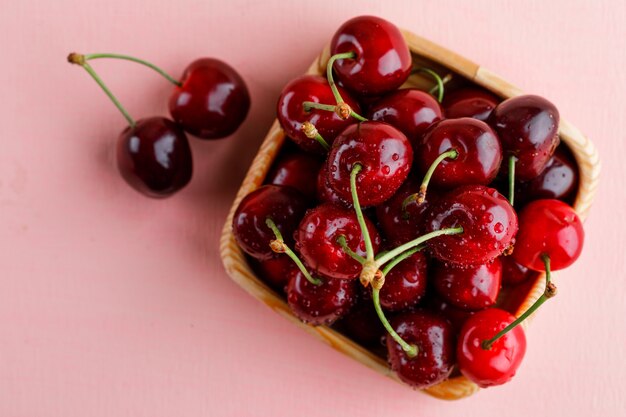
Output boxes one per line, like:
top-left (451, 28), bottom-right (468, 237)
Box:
top-left (220, 31), bottom-right (600, 400)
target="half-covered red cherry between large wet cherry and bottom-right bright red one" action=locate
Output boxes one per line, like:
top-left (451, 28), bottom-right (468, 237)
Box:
top-left (431, 258), bottom-right (502, 310)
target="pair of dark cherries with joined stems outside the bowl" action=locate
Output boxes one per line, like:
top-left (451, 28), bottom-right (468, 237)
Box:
top-left (68, 53), bottom-right (250, 198)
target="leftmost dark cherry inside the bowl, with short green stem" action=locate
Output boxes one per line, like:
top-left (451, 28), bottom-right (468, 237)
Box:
top-left (233, 185), bottom-right (307, 260)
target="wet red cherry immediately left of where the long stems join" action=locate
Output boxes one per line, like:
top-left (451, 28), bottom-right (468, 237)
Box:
top-left (296, 203), bottom-right (380, 279)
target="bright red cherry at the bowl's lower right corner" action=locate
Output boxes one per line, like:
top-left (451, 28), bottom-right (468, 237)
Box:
top-left (456, 308), bottom-right (526, 388)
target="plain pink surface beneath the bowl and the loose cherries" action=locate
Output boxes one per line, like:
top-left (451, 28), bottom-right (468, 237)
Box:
top-left (0, 0), bottom-right (626, 417)
